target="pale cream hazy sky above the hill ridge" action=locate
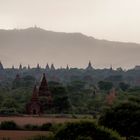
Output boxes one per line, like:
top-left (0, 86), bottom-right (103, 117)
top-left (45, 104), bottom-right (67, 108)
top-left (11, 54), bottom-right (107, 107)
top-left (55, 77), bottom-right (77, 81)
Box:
top-left (0, 0), bottom-right (140, 43)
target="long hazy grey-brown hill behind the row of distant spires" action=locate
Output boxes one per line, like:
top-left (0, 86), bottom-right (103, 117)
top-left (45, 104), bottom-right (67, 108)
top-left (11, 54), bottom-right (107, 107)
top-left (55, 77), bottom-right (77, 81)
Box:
top-left (0, 27), bottom-right (140, 67)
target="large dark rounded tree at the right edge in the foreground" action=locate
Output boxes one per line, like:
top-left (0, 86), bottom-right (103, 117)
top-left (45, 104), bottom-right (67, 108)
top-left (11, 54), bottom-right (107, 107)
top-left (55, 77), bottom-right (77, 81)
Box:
top-left (99, 102), bottom-right (140, 137)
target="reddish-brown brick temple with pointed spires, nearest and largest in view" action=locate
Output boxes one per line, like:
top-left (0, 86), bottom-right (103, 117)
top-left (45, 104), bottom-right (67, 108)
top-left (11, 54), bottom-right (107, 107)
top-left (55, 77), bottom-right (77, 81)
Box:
top-left (26, 73), bottom-right (52, 115)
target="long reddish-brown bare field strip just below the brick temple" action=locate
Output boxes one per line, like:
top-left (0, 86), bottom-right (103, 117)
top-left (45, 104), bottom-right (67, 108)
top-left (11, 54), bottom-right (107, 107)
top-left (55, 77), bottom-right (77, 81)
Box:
top-left (0, 116), bottom-right (77, 126)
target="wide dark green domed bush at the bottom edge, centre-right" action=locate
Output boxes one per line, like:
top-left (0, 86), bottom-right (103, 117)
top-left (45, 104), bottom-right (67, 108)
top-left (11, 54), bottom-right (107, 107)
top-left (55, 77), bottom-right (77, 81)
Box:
top-left (55, 121), bottom-right (122, 140)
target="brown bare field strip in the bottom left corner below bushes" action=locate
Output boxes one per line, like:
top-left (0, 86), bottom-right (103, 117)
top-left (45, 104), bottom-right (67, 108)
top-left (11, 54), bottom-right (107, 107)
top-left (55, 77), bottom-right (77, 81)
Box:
top-left (0, 130), bottom-right (48, 140)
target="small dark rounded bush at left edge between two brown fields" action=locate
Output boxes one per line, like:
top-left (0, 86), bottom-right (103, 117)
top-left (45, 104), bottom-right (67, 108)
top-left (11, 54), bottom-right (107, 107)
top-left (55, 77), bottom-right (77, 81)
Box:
top-left (0, 121), bottom-right (19, 130)
